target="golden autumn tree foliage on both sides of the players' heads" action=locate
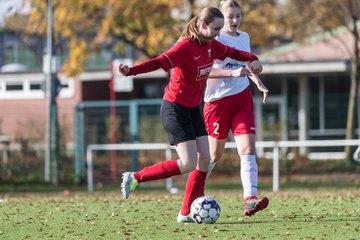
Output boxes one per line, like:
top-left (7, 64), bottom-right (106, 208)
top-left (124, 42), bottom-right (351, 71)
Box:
top-left (19, 0), bottom-right (282, 76)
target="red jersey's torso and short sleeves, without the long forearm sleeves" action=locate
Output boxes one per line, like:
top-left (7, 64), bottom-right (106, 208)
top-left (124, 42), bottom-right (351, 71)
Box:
top-left (163, 39), bottom-right (222, 108)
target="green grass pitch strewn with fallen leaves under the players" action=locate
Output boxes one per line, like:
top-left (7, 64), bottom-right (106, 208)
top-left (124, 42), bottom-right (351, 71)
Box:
top-left (0, 183), bottom-right (360, 240)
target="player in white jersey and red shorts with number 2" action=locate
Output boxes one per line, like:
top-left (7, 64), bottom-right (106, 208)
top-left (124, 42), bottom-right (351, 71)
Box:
top-left (204, 0), bottom-right (269, 216)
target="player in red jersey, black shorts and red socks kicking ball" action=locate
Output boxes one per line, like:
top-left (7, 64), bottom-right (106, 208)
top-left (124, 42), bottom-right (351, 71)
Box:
top-left (118, 7), bottom-right (262, 222)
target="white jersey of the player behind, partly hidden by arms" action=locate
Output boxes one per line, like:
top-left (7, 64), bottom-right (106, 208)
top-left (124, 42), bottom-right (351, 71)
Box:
top-left (204, 30), bottom-right (251, 102)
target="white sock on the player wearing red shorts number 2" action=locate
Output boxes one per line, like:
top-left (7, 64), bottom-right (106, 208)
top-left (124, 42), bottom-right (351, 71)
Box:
top-left (240, 155), bottom-right (258, 198)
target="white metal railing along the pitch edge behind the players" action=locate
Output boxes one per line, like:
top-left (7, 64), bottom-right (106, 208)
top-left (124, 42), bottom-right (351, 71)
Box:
top-left (86, 139), bottom-right (360, 192)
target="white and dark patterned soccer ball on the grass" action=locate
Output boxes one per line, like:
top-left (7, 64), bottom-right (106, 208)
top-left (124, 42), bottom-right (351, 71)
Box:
top-left (190, 196), bottom-right (220, 224)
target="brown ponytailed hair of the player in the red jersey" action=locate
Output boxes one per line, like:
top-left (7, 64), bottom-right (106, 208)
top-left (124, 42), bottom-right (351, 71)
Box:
top-left (178, 7), bottom-right (224, 42)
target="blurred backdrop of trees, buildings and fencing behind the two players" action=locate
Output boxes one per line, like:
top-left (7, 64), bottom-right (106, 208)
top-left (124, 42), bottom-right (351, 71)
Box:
top-left (0, 0), bottom-right (360, 191)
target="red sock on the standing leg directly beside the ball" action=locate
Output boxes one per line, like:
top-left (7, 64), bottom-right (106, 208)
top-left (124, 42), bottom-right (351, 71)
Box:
top-left (181, 169), bottom-right (207, 216)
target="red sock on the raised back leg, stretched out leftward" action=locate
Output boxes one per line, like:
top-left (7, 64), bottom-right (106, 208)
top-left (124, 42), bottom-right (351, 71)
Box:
top-left (134, 160), bottom-right (181, 183)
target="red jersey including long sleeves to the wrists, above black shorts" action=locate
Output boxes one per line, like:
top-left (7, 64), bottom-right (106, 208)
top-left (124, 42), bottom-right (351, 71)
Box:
top-left (128, 39), bottom-right (257, 108)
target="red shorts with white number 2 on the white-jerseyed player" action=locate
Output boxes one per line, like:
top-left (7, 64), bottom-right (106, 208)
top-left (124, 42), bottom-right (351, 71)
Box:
top-left (204, 87), bottom-right (256, 139)
